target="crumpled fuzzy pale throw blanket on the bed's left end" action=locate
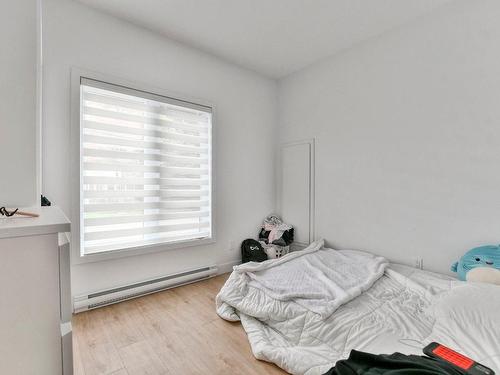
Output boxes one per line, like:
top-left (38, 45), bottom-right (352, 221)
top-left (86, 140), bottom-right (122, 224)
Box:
top-left (216, 240), bottom-right (388, 320)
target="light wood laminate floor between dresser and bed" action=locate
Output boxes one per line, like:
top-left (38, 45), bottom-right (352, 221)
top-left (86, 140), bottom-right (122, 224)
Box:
top-left (73, 274), bottom-right (286, 375)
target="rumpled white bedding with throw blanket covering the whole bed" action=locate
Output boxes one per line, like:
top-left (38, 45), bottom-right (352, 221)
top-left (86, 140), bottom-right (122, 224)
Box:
top-left (216, 243), bottom-right (500, 375)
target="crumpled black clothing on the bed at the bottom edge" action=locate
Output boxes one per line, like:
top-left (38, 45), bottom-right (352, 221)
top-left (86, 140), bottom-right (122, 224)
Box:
top-left (324, 350), bottom-right (466, 375)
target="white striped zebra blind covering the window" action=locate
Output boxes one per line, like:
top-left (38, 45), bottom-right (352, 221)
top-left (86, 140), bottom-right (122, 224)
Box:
top-left (80, 77), bottom-right (212, 255)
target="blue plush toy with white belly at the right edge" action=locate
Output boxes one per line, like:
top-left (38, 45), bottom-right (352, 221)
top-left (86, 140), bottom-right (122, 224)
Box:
top-left (451, 245), bottom-right (500, 285)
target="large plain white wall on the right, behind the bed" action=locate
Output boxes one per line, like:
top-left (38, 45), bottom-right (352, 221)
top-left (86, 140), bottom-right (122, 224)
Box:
top-left (279, 0), bottom-right (500, 272)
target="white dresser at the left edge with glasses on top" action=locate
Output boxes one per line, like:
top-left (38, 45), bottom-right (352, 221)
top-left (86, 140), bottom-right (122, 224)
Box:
top-left (0, 207), bottom-right (73, 375)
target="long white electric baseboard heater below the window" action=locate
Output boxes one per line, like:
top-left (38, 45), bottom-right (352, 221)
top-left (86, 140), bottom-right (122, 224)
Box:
top-left (73, 266), bottom-right (217, 313)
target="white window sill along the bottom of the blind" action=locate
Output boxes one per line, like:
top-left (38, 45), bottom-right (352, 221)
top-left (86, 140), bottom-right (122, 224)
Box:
top-left (73, 237), bottom-right (216, 264)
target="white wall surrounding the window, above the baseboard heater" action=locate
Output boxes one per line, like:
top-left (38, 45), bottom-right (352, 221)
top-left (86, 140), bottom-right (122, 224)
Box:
top-left (43, 0), bottom-right (277, 295)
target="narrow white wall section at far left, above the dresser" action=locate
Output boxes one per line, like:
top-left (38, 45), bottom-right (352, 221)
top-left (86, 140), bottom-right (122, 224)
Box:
top-left (0, 0), bottom-right (37, 207)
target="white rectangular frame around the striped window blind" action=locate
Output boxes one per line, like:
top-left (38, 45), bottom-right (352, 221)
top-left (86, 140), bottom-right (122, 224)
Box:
top-left (70, 68), bottom-right (216, 264)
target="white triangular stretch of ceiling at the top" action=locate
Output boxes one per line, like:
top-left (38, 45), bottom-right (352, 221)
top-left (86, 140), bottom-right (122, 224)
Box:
top-left (75, 0), bottom-right (450, 78)
